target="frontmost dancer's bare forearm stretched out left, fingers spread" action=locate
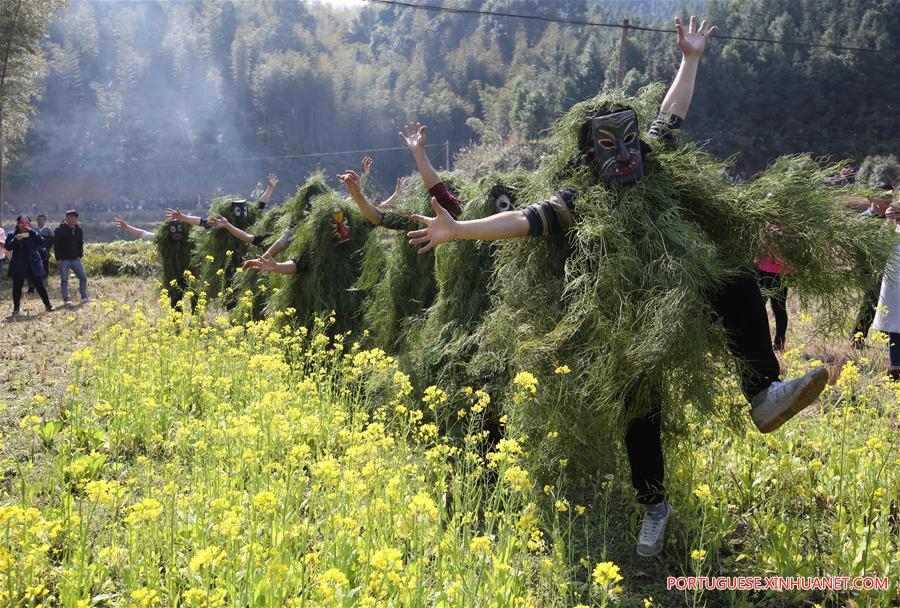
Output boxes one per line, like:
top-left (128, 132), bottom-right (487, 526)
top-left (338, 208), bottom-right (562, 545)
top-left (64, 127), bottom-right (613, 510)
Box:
top-left (407, 197), bottom-right (529, 253)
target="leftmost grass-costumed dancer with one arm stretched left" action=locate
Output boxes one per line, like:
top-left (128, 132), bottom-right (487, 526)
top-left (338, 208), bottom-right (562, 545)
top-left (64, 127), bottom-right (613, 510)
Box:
top-left (116, 215), bottom-right (194, 308)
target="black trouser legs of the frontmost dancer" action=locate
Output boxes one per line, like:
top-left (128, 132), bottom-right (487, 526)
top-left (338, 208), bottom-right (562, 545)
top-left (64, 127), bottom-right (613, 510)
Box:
top-left (625, 274), bottom-right (780, 504)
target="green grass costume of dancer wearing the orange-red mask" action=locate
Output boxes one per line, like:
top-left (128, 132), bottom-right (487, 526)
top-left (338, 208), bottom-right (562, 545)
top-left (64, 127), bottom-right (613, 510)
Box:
top-left (266, 192), bottom-right (372, 332)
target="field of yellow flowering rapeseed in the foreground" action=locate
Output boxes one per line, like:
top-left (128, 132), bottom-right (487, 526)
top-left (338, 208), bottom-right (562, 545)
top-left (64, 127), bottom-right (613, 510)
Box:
top-left (0, 288), bottom-right (900, 608)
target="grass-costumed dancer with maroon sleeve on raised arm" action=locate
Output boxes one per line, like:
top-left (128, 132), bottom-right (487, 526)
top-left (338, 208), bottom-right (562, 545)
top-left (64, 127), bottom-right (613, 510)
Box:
top-left (338, 123), bottom-right (465, 354)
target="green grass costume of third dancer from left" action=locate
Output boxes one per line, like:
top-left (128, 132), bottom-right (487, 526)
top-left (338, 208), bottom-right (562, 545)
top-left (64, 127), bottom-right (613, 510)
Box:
top-left (232, 171), bottom-right (331, 322)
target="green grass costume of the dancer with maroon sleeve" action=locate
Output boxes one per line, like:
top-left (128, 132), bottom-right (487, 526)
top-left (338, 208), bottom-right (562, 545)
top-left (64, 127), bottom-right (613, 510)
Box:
top-left (360, 173), bottom-right (465, 353)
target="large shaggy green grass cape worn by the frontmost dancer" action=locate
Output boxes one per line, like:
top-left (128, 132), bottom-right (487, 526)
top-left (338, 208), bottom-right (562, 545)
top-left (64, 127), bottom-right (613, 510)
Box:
top-left (470, 85), bottom-right (891, 480)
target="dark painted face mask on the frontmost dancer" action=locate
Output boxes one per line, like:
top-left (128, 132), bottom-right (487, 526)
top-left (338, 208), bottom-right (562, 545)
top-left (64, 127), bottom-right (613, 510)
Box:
top-left (591, 110), bottom-right (644, 184)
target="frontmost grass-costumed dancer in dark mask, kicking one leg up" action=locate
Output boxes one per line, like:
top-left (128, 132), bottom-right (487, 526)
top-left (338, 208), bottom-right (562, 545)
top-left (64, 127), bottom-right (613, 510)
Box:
top-left (409, 17), bottom-right (889, 556)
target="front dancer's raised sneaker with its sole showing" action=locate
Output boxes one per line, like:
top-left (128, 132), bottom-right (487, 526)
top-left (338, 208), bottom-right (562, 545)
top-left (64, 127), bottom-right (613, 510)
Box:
top-left (750, 365), bottom-right (828, 433)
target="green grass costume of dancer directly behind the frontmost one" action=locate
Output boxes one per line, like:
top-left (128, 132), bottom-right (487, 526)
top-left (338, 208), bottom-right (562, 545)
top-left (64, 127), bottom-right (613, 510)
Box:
top-left (409, 171), bottom-right (528, 404)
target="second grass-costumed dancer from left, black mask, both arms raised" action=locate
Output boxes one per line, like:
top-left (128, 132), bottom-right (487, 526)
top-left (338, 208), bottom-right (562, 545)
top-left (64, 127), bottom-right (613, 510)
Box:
top-left (165, 175), bottom-right (278, 309)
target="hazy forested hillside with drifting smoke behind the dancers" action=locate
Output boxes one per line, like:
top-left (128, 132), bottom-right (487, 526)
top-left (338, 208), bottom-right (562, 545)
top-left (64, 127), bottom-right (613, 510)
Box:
top-left (7, 0), bottom-right (900, 201)
